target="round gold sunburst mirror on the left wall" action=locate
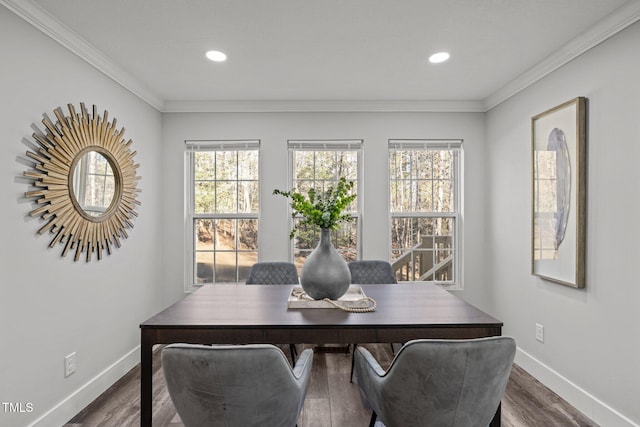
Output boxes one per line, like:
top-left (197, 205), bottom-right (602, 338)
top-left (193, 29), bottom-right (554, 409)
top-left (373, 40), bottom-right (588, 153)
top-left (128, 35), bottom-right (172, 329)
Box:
top-left (24, 103), bottom-right (140, 262)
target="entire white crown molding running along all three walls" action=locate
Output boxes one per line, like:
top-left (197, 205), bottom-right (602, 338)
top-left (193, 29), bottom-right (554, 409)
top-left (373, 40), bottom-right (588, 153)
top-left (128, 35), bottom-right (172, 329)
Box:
top-left (5, 0), bottom-right (640, 113)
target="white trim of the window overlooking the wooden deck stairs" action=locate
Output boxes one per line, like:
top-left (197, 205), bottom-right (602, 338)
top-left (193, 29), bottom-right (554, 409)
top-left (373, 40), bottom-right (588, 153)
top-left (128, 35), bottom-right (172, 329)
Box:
top-left (387, 139), bottom-right (464, 290)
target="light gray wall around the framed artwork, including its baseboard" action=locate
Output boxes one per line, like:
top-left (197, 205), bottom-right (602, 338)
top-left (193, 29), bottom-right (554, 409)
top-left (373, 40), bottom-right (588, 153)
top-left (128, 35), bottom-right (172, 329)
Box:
top-left (486, 19), bottom-right (640, 426)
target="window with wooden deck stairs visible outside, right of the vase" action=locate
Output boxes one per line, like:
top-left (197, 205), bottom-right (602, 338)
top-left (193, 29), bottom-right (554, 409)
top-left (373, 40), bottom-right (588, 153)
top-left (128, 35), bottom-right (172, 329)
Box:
top-left (389, 140), bottom-right (462, 288)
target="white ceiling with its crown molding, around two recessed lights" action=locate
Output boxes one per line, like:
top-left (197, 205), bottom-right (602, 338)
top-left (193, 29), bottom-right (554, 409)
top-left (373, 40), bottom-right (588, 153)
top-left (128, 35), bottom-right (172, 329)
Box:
top-left (5, 0), bottom-right (640, 111)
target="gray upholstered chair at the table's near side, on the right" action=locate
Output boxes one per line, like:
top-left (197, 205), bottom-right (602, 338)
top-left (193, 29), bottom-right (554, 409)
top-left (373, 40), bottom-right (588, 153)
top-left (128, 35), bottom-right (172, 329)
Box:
top-left (356, 337), bottom-right (516, 427)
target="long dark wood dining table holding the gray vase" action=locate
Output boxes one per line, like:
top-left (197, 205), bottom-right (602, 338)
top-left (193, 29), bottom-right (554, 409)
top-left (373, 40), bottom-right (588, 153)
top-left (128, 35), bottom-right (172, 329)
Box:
top-left (140, 282), bottom-right (502, 426)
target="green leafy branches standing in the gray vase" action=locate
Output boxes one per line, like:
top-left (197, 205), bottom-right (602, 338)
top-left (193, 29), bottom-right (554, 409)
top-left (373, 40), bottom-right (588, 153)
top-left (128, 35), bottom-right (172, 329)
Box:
top-left (273, 178), bottom-right (356, 239)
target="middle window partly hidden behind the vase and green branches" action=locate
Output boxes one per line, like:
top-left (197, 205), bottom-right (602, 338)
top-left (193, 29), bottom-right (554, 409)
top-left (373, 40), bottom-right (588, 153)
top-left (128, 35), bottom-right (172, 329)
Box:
top-left (288, 140), bottom-right (362, 268)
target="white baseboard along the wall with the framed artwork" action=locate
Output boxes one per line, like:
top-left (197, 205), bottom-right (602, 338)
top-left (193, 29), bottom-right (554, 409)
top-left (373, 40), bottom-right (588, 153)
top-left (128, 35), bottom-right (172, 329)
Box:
top-left (515, 348), bottom-right (640, 427)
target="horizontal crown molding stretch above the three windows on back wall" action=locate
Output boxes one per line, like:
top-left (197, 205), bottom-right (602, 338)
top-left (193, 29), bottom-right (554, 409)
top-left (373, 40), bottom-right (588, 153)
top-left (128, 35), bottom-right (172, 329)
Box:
top-left (162, 100), bottom-right (485, 113)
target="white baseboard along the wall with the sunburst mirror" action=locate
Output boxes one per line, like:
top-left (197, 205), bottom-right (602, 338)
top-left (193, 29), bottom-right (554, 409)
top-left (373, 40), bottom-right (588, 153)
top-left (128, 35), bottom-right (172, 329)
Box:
top-left (29, 345), bottom-right (140, 427)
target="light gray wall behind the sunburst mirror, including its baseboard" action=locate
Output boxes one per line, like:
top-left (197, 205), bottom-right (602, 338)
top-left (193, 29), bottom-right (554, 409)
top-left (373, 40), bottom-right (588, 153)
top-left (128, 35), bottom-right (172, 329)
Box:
top-left (0, 6), bottom-right (163, 426)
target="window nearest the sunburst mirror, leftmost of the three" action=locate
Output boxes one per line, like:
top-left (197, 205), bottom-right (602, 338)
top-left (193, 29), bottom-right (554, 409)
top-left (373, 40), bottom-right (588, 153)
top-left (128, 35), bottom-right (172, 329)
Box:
top-left (186, 141), bottom-right (259, 288)
